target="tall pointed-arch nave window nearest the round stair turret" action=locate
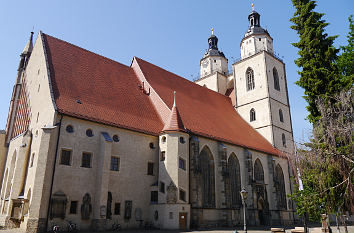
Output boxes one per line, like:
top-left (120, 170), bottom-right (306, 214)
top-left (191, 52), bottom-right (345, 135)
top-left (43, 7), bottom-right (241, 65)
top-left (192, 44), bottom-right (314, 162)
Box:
top-left (200, 147), bottom-right (215, 207)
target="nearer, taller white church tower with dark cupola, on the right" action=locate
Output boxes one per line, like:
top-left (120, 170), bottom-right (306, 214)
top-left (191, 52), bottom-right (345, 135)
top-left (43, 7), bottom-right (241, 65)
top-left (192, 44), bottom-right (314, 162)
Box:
top-left (233, 5), bottom-right (294, 153)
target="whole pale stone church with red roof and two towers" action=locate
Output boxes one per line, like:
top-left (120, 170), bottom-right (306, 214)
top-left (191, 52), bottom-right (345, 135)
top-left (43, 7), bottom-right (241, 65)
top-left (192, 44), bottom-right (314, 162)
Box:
top-left (0, 6), bottom-right (295, 233)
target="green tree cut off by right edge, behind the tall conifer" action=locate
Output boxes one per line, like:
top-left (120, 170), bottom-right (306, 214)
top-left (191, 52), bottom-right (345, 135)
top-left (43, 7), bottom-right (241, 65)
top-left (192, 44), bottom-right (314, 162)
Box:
top-left (337, 15), bottom-right (354, 87)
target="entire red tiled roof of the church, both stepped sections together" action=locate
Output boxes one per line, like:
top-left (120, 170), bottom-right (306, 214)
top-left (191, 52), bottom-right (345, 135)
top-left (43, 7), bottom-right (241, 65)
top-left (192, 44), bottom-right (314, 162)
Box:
top-left (41, 33), bottom-right (283, 156)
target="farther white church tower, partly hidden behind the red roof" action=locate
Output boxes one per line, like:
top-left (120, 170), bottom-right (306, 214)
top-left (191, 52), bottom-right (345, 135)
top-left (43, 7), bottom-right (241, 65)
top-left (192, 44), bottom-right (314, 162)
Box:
top-left (196, 29), bottom-right (232, 94)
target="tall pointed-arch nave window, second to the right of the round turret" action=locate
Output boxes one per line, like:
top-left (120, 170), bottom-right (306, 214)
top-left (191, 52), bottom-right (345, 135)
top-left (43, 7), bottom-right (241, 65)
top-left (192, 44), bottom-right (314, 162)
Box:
top-left (227, 154), bottom-right (241, 208)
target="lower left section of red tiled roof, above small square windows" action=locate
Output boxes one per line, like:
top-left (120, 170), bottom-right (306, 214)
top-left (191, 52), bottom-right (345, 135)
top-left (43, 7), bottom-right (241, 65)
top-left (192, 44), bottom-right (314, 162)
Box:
top-left (42, 33), bottom-right (163, 135)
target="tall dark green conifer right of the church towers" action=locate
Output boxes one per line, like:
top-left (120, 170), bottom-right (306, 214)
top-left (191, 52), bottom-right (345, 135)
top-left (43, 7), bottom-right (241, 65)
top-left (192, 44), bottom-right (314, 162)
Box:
top-left (290, 0), bottom-right (342, 123)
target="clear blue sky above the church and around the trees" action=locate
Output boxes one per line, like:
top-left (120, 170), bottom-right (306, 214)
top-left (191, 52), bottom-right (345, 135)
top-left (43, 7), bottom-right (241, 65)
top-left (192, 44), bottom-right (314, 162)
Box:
top-left (0, 0), bottom-right (354, 141)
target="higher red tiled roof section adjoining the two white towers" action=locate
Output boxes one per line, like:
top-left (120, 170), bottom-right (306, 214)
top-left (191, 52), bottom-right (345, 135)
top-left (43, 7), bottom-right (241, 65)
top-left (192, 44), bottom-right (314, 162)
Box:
top-left (136, 58), bottom-right (282, 156)
